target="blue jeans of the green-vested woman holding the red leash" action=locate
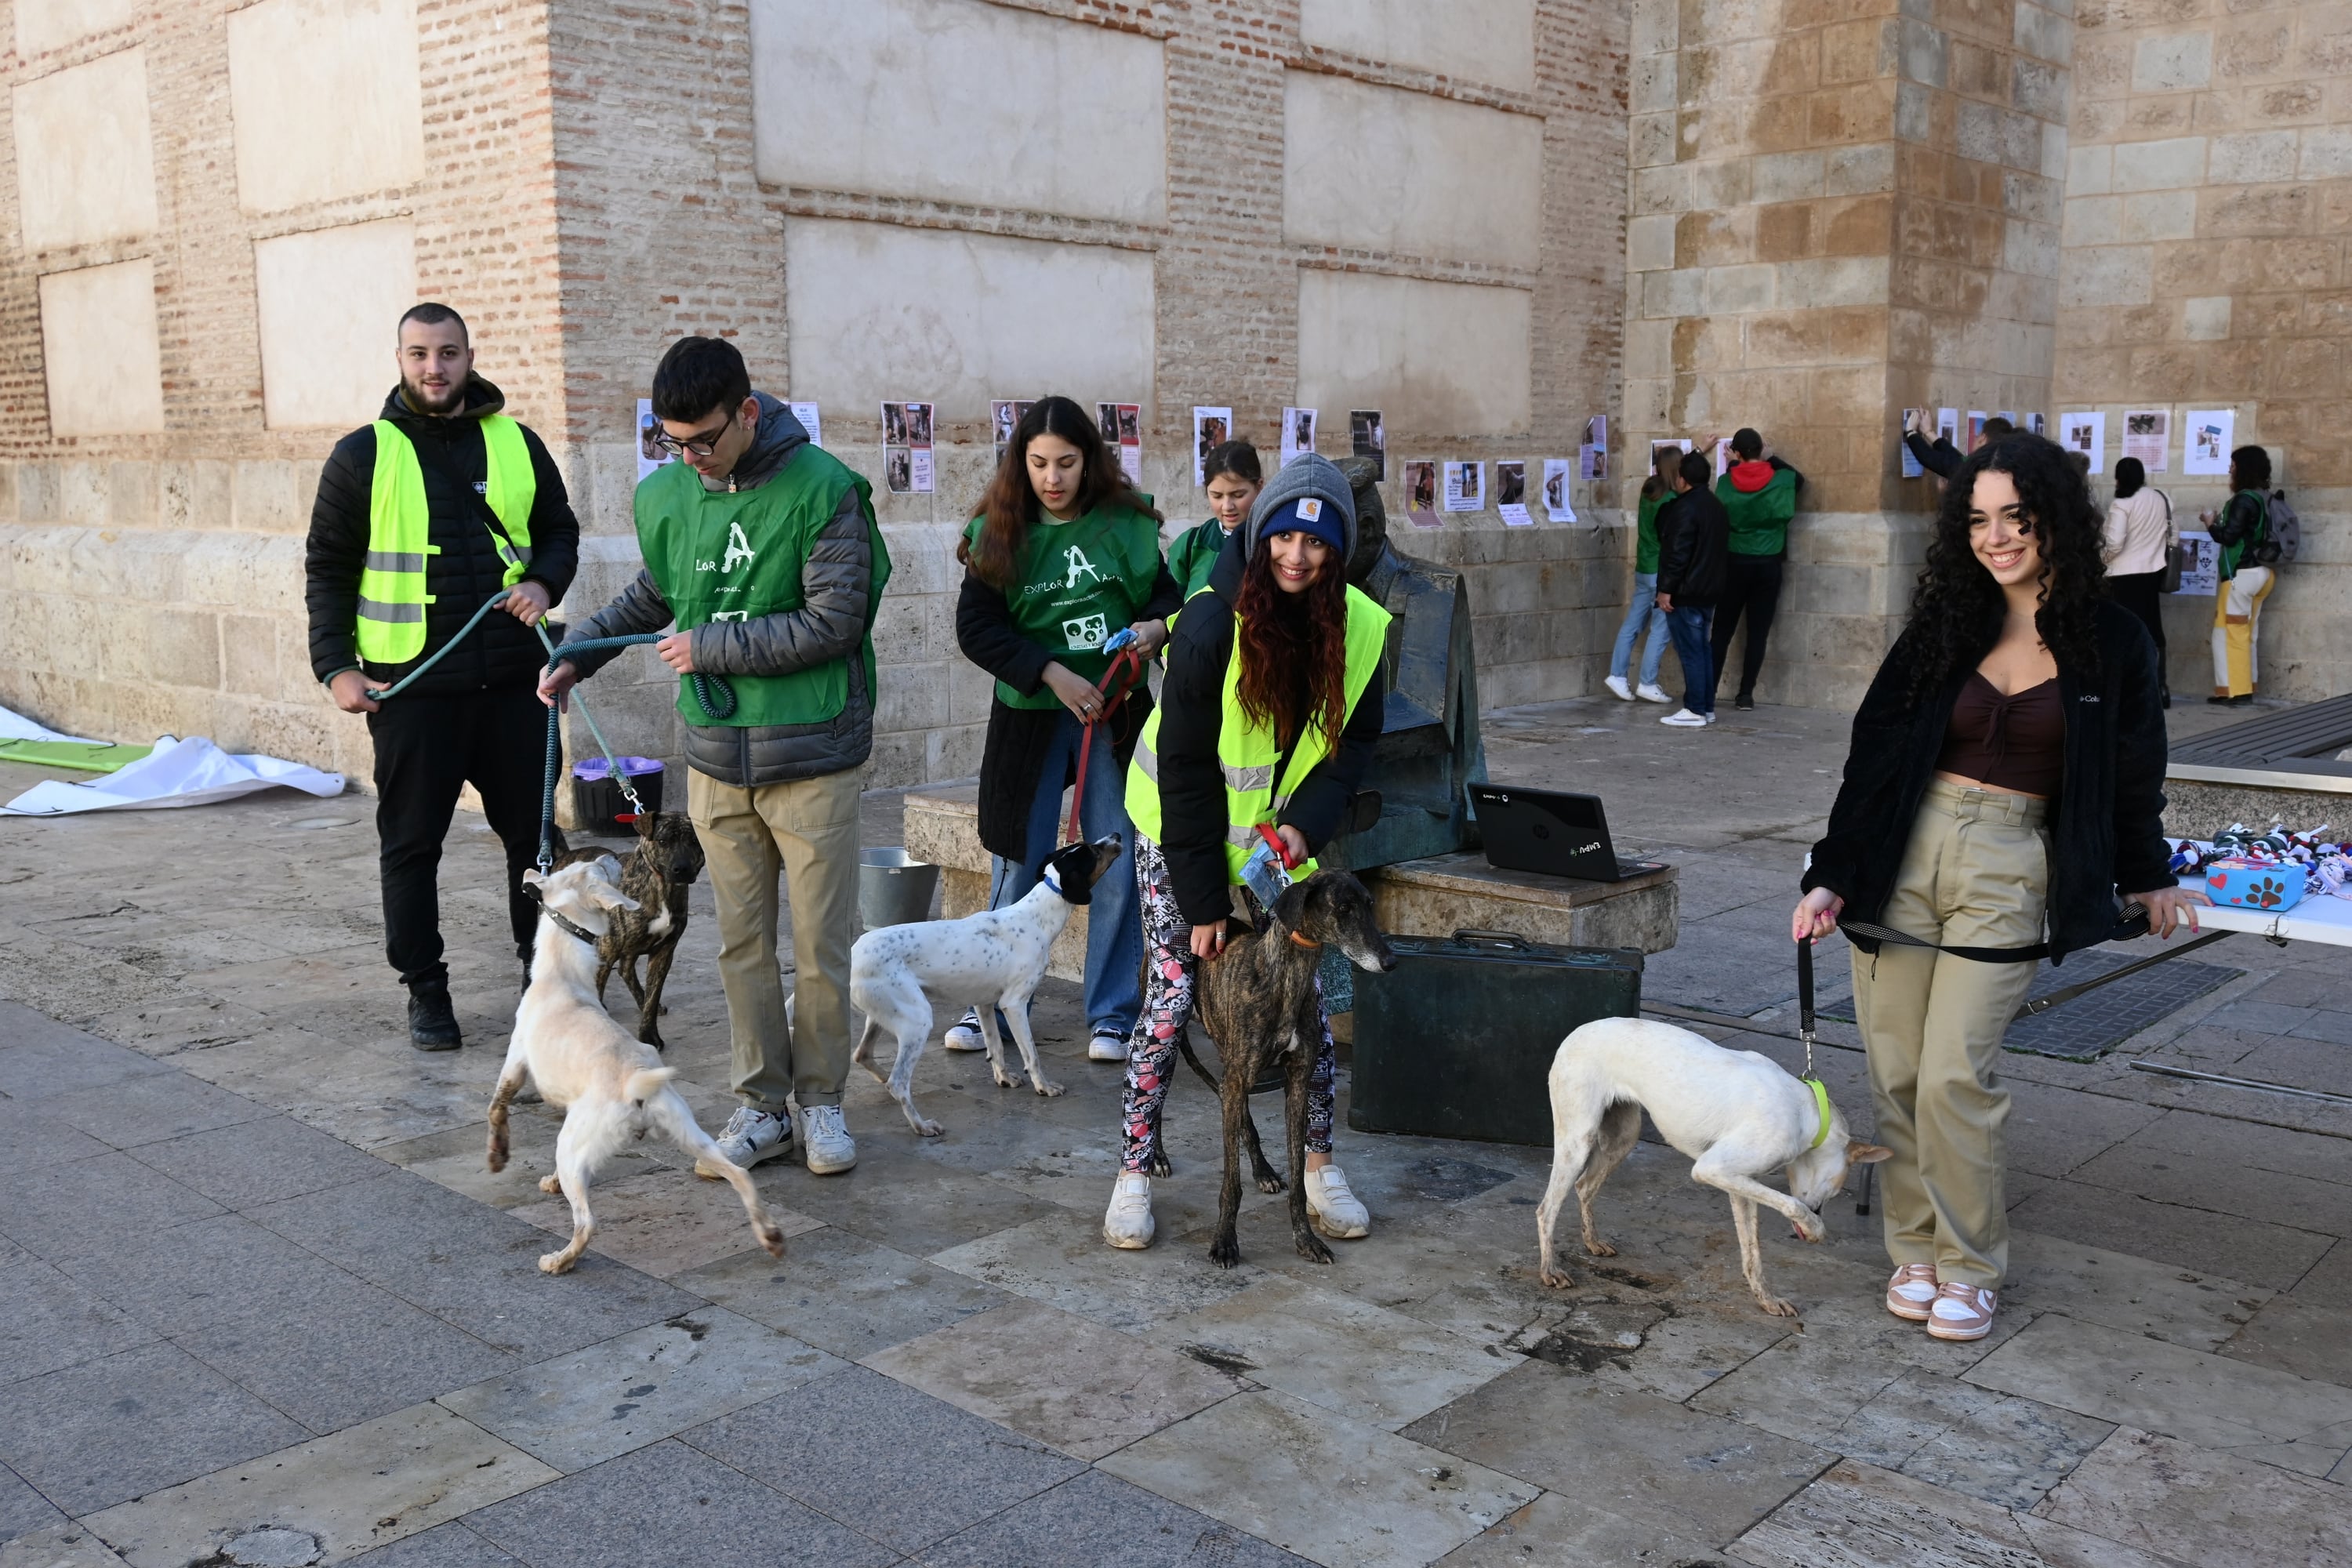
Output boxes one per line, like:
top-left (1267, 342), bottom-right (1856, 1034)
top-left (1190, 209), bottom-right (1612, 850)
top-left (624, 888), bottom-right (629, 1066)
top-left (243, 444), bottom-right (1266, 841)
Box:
top-left (988, 710), bottom-right (1143, 1039)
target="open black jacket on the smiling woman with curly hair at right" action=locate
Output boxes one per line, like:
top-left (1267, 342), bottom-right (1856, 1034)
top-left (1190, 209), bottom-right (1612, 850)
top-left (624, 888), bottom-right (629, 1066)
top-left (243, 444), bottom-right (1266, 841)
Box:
top-left (1804, 602), bottom-right (2173, 964)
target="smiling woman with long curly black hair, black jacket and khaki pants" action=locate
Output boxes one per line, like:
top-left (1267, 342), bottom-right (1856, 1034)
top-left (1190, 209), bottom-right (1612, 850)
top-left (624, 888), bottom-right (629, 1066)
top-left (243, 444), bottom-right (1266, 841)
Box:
top-left (1790, 435), bottom-right (2206, 1340)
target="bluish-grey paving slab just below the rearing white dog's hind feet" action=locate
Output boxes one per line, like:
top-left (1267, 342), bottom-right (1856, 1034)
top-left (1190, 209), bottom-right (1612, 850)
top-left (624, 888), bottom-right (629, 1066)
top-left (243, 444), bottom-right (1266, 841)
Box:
top-left (440, 1307), bottom-right (842, 1474)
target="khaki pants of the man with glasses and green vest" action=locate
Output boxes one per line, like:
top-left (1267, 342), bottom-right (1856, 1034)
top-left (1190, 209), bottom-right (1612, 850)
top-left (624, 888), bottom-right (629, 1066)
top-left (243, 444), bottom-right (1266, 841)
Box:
top-left (687, 769), bottom-right (858, 1116)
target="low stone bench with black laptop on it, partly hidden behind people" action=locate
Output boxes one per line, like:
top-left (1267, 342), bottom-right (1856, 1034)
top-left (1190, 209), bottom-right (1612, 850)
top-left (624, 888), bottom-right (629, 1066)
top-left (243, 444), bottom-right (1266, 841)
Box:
top-left (906, 785), bottom-right (1682, 980)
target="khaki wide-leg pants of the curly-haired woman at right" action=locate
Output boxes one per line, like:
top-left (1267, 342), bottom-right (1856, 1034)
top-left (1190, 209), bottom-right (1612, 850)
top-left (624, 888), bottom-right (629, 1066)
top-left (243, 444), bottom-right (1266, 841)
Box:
top-left (1853, 781), bottom-right (2049, 1290)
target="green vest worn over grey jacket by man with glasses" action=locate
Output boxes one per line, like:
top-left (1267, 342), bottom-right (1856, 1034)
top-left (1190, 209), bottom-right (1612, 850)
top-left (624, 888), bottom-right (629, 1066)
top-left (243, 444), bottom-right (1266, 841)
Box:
top-left (637, 445), bottom-right (889, 729)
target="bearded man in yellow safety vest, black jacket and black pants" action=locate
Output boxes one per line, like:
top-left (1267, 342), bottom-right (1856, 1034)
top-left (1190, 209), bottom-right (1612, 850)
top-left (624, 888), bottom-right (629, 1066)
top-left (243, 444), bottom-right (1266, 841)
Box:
top-left (303, 303), bottom-right (579, 1051)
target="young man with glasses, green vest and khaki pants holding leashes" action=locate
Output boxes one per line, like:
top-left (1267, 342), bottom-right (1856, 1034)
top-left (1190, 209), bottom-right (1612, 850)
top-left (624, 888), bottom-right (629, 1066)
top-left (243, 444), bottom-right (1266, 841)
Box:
top-left (539, 339), bottom-right (889, 1175)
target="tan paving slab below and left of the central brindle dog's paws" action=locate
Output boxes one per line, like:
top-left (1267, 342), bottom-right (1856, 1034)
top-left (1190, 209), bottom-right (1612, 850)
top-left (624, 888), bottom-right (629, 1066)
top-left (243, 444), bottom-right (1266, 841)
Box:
top-left (866, 1298), bottom-right (1254, 1460)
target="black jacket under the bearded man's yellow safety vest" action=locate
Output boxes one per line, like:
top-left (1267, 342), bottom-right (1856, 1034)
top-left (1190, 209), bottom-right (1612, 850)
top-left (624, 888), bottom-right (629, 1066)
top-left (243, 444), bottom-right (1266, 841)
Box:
top-left (303, 376), bottom-right (581, 696)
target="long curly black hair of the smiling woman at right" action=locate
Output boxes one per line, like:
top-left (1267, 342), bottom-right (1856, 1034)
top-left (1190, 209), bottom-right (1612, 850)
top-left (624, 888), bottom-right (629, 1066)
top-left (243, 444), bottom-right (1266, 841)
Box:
top-left (1903, 435), bottom-right (2107, 703)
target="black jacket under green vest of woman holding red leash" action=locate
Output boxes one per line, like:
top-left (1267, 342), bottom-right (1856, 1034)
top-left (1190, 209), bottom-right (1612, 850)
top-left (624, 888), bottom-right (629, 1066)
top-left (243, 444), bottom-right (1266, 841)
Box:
top-left (955, 517), bottom-right (1185, 860)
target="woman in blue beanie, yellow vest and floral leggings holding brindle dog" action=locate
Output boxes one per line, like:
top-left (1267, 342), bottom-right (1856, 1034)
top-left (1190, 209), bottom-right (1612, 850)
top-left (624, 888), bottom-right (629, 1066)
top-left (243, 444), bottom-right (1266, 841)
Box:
top-left (1096, 454), bottom-right (1388, 1248)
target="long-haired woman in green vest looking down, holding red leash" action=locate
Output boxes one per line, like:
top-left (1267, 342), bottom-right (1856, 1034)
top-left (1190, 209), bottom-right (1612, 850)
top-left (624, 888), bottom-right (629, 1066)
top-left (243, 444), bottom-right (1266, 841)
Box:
top-left (946, 397), bottom-right (1178, 1062)
